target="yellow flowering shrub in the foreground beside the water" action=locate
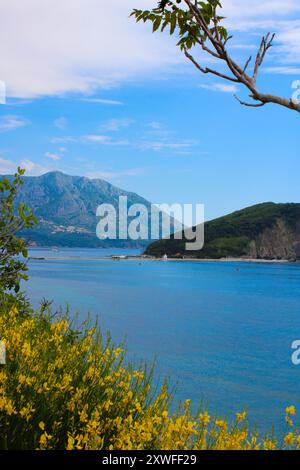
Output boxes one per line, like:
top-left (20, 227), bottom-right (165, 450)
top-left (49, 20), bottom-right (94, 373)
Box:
top-left (0, 308), bottom-right (300, 450)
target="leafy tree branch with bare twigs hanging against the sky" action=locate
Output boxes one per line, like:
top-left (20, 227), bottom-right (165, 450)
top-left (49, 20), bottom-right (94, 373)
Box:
top-left (131, 0), bottom-right (300, 112)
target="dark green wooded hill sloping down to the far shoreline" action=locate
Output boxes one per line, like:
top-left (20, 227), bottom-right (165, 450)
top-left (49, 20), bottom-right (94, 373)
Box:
top-left (147, 203), bottom-right (300, 260)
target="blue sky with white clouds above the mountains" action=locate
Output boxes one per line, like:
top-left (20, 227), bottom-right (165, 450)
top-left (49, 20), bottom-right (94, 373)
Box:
top-left (0, 0), bottom-right (300, 218)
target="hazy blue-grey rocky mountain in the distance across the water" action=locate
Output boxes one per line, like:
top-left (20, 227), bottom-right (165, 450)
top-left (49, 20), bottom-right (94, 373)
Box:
top-left (5, 172), bottom-right (166, 247)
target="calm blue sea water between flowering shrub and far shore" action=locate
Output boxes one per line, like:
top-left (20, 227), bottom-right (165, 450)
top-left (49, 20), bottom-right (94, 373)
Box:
top-left (27, 250), bottom-right (300, 431)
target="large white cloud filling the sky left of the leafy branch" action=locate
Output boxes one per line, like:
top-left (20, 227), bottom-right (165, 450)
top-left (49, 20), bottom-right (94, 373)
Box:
top-left (0, 0), bottom-right (179, 99)
